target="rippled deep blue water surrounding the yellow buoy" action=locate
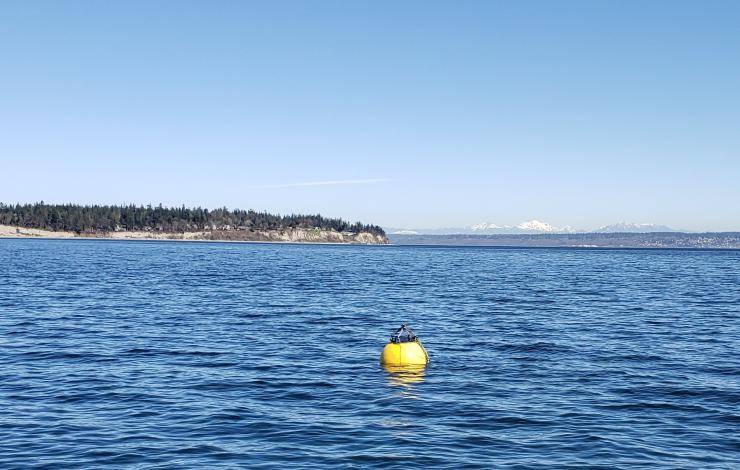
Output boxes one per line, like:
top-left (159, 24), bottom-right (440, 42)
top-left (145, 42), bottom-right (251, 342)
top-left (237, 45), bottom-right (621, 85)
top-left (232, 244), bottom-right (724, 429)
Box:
top-left (0, 240), bottom-right (740, 469)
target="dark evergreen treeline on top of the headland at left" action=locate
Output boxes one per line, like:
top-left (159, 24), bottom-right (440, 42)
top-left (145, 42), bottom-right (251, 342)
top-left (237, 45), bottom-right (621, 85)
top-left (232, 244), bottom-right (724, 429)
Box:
top-left (0, 201), bottom-right (385, 235)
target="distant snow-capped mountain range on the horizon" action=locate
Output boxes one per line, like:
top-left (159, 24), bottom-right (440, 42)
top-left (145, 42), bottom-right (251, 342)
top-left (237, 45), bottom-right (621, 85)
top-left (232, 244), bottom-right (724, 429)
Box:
top-left (385, 219), bottom-right (679, 235)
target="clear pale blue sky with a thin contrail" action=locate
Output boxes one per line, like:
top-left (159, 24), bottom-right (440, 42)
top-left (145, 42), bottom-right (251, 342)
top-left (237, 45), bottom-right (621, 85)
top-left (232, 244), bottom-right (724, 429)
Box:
top-left (0, 0), bottom-right (740, 230)
